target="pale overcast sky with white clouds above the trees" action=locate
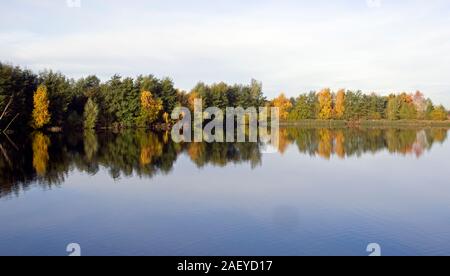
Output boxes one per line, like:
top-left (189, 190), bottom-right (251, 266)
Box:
top-left (0, 0), bottom-right (450, 107)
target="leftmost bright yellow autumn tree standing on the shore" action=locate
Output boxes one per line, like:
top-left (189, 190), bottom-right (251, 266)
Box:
top-left (32, 85), bottom-right (51, 129)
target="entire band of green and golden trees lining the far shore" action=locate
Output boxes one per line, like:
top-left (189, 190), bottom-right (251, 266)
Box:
top-left (0, 63), bottom-right (448, 130)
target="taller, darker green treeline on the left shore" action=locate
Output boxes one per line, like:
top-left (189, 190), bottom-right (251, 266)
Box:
top-left (0, 63), bottom-right (266, 132)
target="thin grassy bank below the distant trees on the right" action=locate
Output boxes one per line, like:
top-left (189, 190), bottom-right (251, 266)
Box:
top-left (280, 120), bottom-right (450, 128)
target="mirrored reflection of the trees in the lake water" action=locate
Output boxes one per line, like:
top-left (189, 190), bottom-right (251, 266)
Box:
top-left (0, 128), bottom-right (448, 197)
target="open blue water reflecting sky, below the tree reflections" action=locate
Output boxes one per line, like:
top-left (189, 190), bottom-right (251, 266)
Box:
top-left (0, 128), bottom-right (450, 256)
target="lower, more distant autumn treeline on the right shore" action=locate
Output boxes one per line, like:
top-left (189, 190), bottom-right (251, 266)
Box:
top-left (271, 89), bottom-right (448, 121)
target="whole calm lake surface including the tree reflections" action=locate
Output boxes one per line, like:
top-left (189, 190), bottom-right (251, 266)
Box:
top-left (0, 128), bottom-right (450, 256)
